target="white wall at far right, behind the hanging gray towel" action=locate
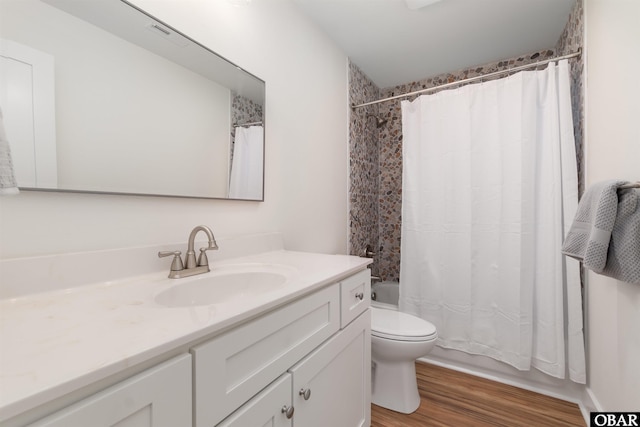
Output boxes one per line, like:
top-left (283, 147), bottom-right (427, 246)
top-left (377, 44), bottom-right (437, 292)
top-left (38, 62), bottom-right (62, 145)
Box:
top-left (586, 0), bottom-right (640, 411)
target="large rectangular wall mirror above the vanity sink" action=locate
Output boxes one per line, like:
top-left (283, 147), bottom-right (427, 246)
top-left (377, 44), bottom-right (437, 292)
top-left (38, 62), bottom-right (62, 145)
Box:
top-left (0, 0), bottom-right (265, 200)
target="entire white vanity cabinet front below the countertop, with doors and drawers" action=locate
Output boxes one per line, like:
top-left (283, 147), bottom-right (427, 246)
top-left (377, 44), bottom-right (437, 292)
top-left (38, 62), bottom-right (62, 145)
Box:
top-left (8, 269), bottom-right (371, 427)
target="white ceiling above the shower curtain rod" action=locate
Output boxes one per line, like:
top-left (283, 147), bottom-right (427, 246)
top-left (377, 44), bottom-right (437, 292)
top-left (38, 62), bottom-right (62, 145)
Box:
top-left (294, 0), bottom-right (576, 88)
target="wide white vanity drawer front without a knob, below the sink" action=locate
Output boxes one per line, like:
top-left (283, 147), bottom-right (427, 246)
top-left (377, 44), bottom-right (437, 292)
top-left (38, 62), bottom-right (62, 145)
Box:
top-left (191, 284), bottom-right (340, 427)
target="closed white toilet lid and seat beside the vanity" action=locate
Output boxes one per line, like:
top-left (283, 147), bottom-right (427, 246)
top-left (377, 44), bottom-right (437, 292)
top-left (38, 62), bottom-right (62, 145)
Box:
top-left (371, 307), bottom-right (437, 341)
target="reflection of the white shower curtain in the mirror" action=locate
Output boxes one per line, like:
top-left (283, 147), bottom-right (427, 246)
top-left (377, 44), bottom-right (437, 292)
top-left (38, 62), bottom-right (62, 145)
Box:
top-left (229, 126), bottom-right (264, 200)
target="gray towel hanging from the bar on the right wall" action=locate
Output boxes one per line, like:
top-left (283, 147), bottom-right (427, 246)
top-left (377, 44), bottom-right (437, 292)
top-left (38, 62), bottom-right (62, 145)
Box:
top-left (562, 180), bottom-right (640, 283)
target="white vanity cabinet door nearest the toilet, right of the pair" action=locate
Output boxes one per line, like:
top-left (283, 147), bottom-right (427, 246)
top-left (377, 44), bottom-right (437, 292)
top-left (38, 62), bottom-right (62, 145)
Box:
top-left (290, 310), bottom-right (371, 427)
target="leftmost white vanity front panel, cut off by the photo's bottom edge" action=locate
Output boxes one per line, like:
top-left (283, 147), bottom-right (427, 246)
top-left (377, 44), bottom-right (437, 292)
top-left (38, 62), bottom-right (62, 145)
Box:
top-left (31, 354), bottom-right (192, 427)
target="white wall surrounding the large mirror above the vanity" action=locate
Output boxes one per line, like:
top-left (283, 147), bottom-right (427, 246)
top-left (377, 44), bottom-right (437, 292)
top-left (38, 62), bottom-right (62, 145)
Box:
top-left (0, 0), bottom-right (348, 258)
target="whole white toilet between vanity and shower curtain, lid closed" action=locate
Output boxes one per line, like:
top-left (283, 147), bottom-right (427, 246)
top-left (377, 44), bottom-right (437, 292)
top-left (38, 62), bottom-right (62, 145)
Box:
top-left (371, 304), bottom-right (438, 414)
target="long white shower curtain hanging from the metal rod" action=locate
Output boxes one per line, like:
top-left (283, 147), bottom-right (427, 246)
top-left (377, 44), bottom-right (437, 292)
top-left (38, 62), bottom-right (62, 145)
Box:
top-left (400, 60), bottom-right (586, 383)
